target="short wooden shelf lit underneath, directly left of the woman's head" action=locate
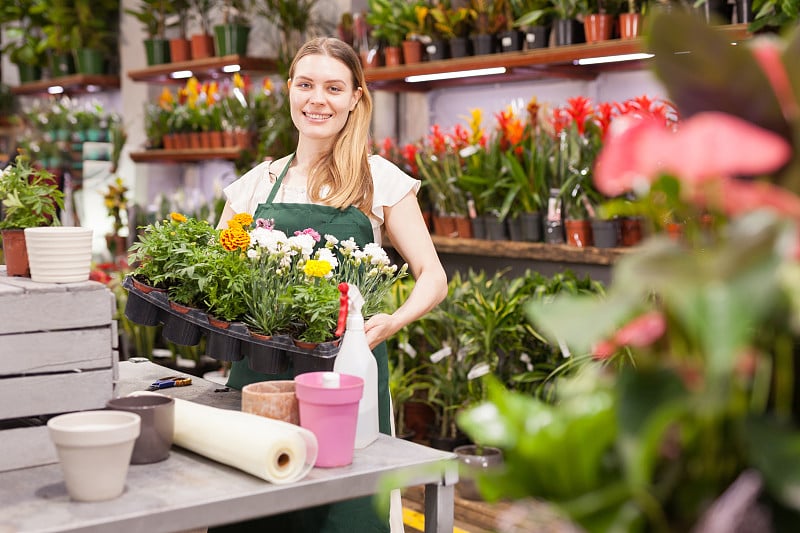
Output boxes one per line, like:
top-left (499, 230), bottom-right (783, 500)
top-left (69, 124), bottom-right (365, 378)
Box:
top-left (128, 55), bottom-right (276, 83)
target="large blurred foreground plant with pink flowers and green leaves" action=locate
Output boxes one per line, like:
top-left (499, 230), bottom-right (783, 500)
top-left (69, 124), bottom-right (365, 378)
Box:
top-left (460, 13), bottom-right (800, 531)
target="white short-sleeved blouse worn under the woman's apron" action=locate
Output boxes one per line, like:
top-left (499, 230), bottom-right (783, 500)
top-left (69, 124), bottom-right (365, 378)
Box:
top-left (219, 155), bottom-right (420, 245)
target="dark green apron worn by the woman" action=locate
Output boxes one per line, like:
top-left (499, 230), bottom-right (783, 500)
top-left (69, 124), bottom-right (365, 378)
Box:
top-left (210, 155), bottom-right (391, 533)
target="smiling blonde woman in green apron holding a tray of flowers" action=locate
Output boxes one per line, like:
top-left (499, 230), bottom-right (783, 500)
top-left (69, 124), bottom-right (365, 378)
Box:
top-left (212, 38), bottom-right (447, 533)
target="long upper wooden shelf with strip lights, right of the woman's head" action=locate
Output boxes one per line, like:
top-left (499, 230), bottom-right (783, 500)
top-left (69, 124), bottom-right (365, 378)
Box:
top-left (365, 24), bottom-right (751, 92)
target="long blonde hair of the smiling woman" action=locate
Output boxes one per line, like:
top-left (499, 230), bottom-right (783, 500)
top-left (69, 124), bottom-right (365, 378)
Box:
top-left (289, 37), bottom-right (373, 217)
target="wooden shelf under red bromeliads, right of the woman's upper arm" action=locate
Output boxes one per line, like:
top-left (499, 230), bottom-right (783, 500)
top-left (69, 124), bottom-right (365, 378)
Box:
top-left (432, 235), bottom-right (634, 265)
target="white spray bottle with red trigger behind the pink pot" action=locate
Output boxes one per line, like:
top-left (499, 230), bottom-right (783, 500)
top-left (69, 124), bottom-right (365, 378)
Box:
top-left (333, 283), bottom-right (378, 449)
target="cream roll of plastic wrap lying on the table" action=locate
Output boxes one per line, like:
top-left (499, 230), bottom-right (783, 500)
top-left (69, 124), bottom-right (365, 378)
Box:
top-left (130, 393), bottom-right (318, 484)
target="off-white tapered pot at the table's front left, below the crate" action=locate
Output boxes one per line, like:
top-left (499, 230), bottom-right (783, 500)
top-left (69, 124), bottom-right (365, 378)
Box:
top-left (47, 410), bottom-right (141, 502)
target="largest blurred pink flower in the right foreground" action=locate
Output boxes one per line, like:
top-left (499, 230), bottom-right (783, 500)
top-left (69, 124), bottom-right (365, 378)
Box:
top-left (595, 112), bottom-right (791, 196)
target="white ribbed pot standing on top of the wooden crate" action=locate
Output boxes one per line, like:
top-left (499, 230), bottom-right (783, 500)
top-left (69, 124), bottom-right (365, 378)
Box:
top-left (25, 226), bottom-right (92, 283)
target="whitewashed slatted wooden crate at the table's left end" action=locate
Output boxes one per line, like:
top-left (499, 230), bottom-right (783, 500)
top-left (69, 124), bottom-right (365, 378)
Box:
top-left (0, 266), bottom-right (118, 471)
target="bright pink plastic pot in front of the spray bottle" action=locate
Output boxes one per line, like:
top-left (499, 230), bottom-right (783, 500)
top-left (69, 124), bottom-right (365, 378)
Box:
top-left (294, 372), bottom-right (364, 467)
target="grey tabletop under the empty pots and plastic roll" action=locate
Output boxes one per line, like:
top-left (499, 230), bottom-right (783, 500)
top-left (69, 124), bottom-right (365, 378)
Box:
top-left (0, 361), bottom-right (458, 533)
